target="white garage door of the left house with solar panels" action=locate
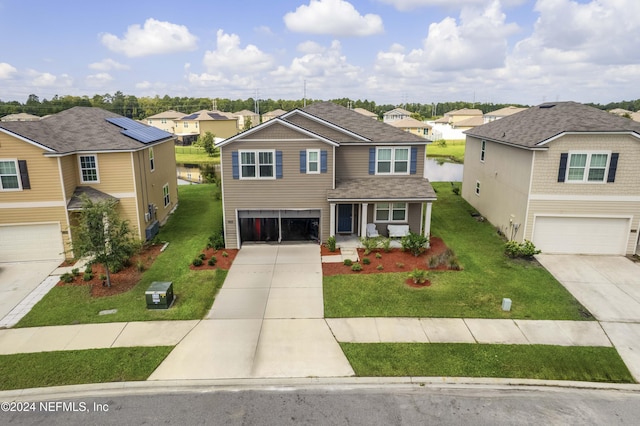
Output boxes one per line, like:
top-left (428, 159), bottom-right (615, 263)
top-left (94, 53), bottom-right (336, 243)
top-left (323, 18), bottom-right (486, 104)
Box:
top-left (0, 223), bottom-right (64, 262)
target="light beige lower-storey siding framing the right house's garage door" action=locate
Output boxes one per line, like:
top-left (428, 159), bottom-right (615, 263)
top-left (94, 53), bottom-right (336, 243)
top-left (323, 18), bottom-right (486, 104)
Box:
top-left (524, 197), bottom-right (640, 254)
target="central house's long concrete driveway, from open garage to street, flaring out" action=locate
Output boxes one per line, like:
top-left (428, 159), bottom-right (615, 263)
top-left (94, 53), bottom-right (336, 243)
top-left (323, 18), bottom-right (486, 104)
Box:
top-left (149, 244), bottom-right (354, 380)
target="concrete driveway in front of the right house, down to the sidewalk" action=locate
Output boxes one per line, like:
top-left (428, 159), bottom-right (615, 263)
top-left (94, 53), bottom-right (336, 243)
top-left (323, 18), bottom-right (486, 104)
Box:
top-left (536, 254), bottom-right (640, 323)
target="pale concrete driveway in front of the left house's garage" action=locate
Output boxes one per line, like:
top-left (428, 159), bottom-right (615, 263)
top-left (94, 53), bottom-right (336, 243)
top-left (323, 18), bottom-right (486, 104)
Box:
top-left (0, 260), bottom-right (61, 324)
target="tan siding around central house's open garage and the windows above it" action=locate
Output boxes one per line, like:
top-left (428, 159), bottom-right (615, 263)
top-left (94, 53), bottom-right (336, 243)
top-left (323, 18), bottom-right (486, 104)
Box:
top-left (221, 135), bottom-right (333, 248)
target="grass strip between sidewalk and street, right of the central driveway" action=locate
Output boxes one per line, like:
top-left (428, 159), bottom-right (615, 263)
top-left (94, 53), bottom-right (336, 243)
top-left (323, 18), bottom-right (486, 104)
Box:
top-left (340, 343), bottom-right (635, 383)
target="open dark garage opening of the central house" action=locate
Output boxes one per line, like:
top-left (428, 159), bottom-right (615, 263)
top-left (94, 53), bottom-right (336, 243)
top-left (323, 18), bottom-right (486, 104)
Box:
top-left (238, 210), bottom-right (320, 243)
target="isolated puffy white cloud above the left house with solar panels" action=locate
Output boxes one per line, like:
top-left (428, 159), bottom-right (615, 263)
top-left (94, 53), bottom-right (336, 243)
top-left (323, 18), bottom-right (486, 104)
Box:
top-left (100, 18), bottom-right (197, 57)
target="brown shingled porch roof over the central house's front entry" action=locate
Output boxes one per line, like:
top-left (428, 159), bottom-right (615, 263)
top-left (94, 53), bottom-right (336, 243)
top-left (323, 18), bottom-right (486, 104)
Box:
top-left (327, 176), bottom-right (437, 202)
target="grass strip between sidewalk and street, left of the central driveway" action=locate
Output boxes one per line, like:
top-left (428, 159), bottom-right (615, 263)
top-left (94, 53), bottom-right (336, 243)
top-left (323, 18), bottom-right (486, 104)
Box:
top-left (0, 346), bottom-right (173, 390)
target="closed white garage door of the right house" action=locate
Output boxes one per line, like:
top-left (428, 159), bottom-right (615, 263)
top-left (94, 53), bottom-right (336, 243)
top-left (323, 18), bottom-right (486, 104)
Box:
top-left (532, 216), bottom-right (629, 255)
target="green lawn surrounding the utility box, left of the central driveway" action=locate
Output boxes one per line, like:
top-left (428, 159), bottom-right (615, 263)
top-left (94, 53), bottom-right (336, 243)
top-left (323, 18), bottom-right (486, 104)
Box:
top-left (16, 185), bottom-right (226, 327)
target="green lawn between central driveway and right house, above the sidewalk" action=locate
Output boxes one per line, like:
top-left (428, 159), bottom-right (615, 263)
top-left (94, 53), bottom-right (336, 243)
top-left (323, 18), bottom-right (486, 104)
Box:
top-left (323, 183), bottom-right (591, 320)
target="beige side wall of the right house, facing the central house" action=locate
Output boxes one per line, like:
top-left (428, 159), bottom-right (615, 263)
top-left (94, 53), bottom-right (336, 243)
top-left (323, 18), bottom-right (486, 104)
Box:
top-left (462, 136), bottom-right (538, 241)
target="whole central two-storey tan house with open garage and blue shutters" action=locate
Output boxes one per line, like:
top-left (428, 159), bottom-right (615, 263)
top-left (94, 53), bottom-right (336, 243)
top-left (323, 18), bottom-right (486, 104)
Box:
top-left (217, 102), bottom-right (436, 248)
